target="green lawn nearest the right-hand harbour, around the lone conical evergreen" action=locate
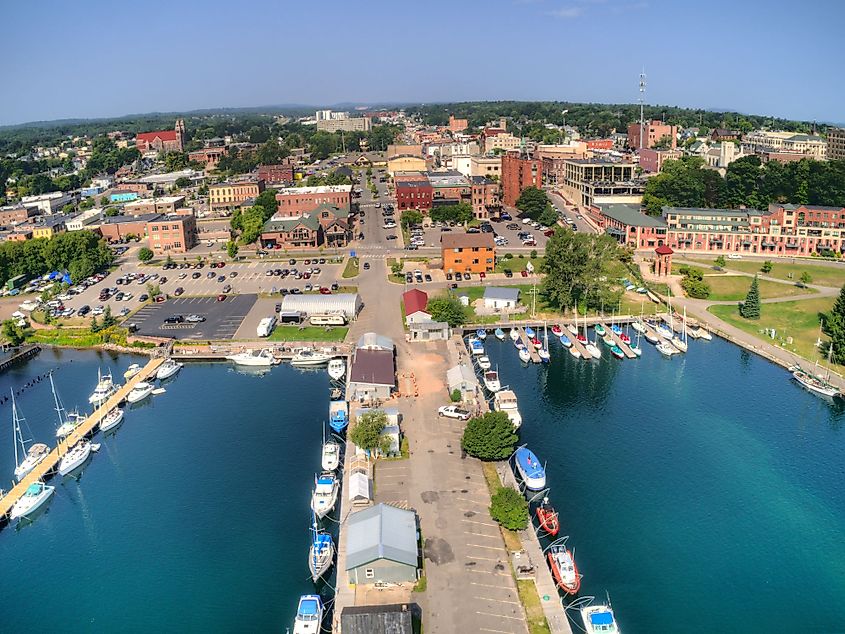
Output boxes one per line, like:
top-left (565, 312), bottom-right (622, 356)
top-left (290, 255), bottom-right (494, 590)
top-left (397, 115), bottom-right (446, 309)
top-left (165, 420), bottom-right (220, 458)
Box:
top-left (707, 297), bottom-right (836, 361)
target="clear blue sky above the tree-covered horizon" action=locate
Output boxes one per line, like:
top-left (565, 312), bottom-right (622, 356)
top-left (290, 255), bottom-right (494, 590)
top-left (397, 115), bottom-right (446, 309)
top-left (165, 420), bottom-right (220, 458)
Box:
top-left (0, 0), bottom-right (845, 125)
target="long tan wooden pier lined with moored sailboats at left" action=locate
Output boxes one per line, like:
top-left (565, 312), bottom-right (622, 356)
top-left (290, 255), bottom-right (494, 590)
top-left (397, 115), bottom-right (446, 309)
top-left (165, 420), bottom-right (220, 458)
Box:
top-left (0, 357), bottom-right (164, 518)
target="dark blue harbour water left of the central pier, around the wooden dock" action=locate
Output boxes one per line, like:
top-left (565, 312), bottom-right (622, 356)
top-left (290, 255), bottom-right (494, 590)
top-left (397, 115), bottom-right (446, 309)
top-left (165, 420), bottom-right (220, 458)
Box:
top-left (0, 350), bottom-right (328, 632)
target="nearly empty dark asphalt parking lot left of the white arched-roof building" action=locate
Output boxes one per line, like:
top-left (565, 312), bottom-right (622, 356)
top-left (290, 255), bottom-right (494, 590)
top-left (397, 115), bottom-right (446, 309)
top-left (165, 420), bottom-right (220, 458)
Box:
top-left (132, 294), bottom-right (258, 339)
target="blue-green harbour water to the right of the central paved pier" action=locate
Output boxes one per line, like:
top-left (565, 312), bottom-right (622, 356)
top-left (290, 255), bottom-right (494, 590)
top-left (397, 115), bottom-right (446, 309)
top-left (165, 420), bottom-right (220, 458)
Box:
top-left (486, 338), bottom-right (845, 634)
